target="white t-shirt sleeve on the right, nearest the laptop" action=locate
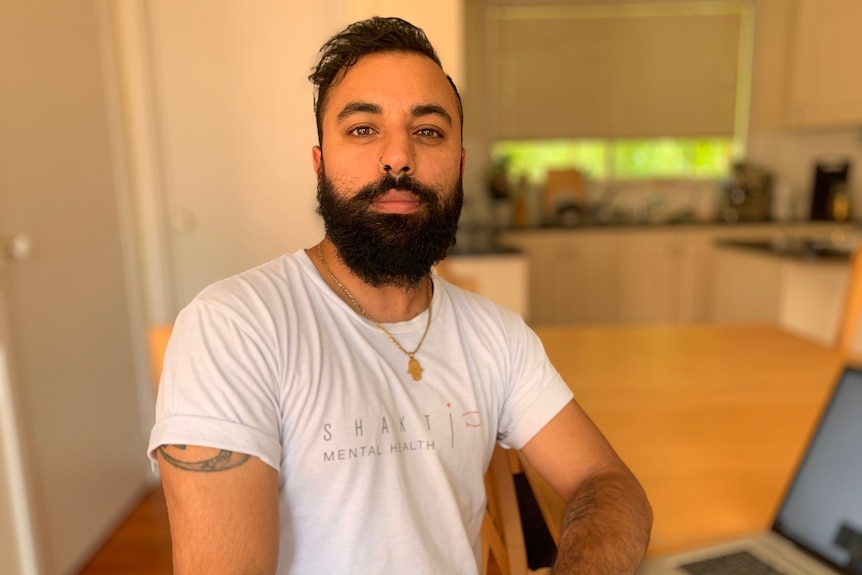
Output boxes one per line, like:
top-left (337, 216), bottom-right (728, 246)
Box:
top-left (497, 318), bottom-right (574, 449)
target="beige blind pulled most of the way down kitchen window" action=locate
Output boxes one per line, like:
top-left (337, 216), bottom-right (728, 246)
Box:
top-left (485, 1), bottom-right (747, 139)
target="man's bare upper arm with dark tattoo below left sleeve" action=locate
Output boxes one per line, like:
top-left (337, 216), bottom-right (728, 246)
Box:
top-left (157, 445), bottom-right (279, 575)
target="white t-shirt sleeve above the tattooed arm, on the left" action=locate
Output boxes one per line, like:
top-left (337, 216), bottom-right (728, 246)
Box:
top-left (147, 299), bottom-right (281, 469)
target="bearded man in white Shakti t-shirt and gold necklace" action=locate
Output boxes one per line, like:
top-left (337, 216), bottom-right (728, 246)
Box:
top-left (150, 18), bottom-right (652, 575)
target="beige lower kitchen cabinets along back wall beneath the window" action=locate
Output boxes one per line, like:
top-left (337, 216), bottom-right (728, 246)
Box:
top-left (500, 222), bottom-right (855, 325)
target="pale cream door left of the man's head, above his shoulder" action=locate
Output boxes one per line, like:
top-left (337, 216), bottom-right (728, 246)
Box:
top-left (142, 0), bottom-right (330, 312)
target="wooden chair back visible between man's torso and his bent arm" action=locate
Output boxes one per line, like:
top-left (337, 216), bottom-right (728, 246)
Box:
top-left (482, 446), bottom-right (550, 575)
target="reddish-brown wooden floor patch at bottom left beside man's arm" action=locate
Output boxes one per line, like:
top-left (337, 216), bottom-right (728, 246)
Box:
top-left (79, 488), bottom-right (173, 575)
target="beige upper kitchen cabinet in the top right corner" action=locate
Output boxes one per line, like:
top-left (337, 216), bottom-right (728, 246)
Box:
top-left (786, 0), bottom-right (862, 127)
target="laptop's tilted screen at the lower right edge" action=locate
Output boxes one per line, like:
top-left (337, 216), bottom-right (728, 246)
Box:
top-left (773, 368), bottom-right (862, 573)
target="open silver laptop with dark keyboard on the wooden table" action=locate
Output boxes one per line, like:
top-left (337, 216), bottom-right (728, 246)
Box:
top-left (637, 367), bottom-right (862, 575)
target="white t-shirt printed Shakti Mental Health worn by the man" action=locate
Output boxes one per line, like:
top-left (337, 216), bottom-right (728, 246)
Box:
top-left (149, 251), bottom-right (572, 574)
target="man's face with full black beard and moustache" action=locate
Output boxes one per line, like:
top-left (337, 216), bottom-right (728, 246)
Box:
top-left (314, 52), bottom-right (464, 287)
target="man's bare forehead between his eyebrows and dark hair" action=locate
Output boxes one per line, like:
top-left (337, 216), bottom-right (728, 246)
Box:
top-left (324, 52), bottom-right (459, 123)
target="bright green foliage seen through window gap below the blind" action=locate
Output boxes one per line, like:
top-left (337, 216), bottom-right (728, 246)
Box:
top-left (491, 138), bottom-right (733, 183)
